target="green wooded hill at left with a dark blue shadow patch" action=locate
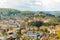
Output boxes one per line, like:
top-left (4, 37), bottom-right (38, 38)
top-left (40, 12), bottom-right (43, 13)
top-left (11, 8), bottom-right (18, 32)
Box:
top-left (0, 8), bottom-right (34, 20)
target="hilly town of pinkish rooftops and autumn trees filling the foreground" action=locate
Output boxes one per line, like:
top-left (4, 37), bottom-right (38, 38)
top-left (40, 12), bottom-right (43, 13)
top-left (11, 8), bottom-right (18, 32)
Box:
top-left (0, 9), bottom-right (60, 40)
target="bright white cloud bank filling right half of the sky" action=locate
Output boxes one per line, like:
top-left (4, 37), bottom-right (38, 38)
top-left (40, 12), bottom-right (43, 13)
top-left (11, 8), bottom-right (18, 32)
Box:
top-left (31, 0), bottom-right (60, 11)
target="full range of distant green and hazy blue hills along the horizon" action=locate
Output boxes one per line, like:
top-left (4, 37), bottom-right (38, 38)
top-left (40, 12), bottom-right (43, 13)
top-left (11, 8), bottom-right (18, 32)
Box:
top-left (0, 8), bottom-right (60, 20)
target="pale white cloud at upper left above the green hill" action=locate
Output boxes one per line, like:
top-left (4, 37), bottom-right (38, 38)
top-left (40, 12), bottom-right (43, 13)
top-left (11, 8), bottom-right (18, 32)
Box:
top-left (0, 0), bottom-right (25, 8)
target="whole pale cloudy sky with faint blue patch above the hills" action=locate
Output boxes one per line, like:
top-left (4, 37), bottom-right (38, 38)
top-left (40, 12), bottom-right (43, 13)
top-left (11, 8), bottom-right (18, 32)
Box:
top-left (0, 0), bottom-right (60, 11)
